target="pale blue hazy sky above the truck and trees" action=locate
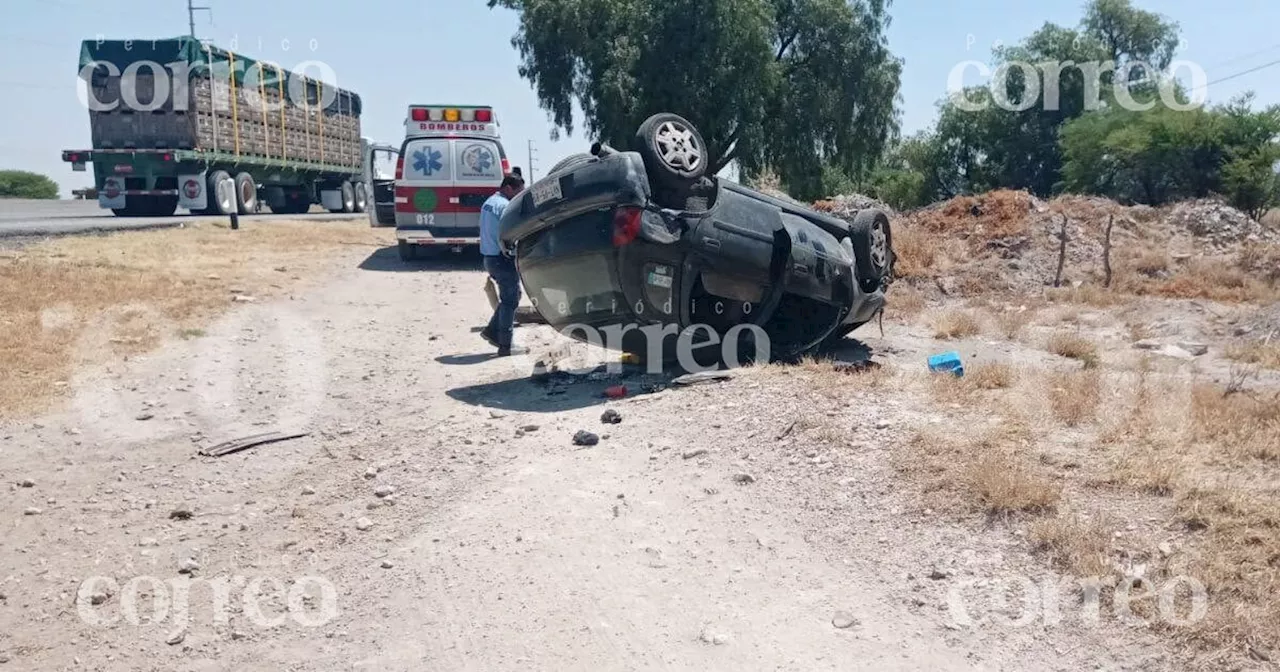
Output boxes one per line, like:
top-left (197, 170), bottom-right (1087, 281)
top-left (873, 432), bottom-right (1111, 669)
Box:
top-left (0, 0), bottom-right (1280, 197)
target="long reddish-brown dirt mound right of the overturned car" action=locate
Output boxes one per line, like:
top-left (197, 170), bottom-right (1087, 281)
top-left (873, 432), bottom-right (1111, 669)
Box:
top-left (893, 189), bottom-right (1280, 296)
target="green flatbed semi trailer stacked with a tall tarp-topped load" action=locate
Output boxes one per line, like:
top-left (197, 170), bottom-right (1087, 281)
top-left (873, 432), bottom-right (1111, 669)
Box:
top-left (63, 37), bottom-right (369, 216)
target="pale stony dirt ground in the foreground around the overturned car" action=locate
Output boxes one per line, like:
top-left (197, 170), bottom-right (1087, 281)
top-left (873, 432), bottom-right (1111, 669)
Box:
top-left (0, 221), bottom-right (1272, 671)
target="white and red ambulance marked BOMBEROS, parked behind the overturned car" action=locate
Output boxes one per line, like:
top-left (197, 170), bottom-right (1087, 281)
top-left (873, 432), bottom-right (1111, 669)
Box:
top-left (370, 105), bottom-right (511, 261)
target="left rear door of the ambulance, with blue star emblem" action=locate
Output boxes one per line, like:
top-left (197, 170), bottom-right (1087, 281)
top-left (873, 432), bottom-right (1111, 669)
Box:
top-left (396, 137), bottom-right (457, 232)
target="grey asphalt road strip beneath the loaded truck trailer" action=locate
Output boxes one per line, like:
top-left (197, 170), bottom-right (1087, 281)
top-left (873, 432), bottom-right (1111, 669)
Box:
top-left (0, 200), bottom-right (369, 238)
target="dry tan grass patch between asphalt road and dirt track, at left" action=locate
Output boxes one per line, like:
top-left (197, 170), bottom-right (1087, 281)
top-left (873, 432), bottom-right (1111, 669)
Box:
top-left (0, 221), bottom-right (372, 417)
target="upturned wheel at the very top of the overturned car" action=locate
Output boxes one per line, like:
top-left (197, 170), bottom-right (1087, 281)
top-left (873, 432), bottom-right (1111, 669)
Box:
top-left (635, 113), bottom-right (708, 192)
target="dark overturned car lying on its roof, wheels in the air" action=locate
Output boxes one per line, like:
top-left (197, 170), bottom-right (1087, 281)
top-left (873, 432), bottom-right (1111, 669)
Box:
top-left (500, 114), bottom-right (893, 365)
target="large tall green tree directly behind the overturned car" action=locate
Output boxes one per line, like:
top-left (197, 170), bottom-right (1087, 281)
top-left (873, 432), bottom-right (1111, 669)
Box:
top-left (489, 0), bottom-right (901, 198)
